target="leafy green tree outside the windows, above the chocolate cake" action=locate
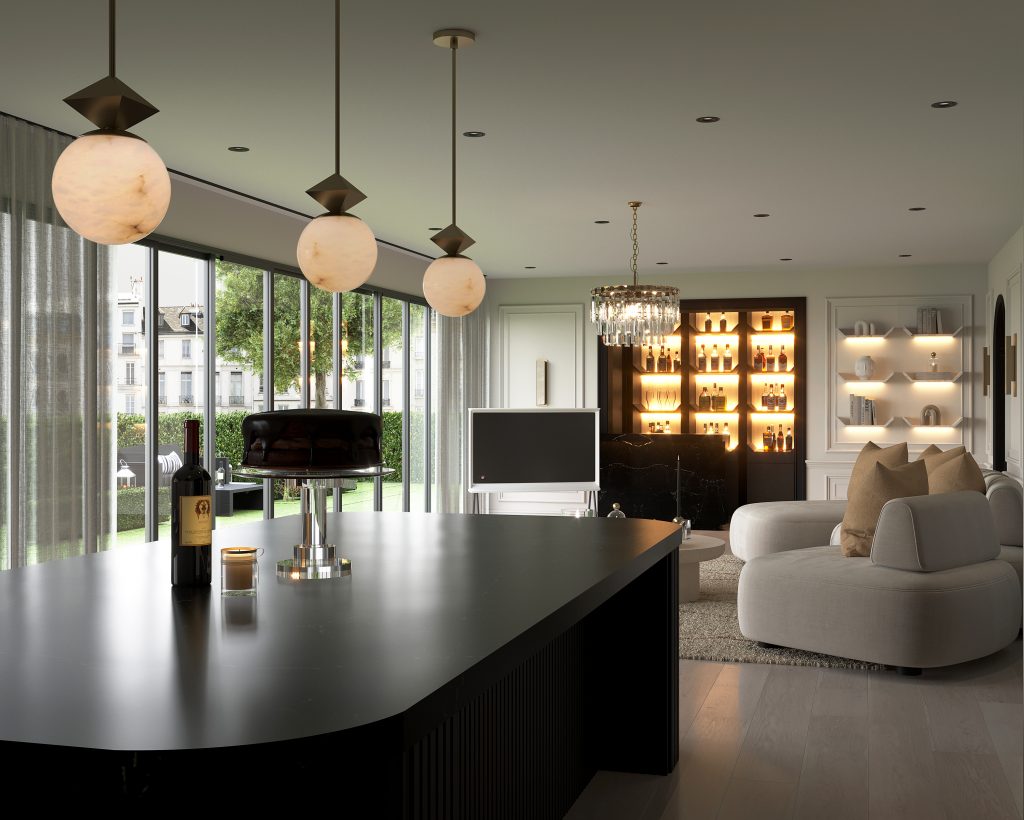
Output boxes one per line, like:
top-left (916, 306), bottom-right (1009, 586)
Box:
top-left (217, 260), bottom-right (401, 407)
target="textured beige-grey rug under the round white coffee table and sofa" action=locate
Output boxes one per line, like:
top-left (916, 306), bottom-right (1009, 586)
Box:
top-left (679, 553), bottom-right (886, 670)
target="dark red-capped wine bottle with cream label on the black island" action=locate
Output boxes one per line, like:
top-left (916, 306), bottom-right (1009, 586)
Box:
top-left (171, 419), bottom-right (213, 587)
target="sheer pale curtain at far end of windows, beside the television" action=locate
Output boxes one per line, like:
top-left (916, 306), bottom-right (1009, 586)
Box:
top-left (434, 299), bottom-right (489, 513)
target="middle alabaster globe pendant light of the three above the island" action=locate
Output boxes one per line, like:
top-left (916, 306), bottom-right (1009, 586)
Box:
top-left (296, 0), bottom-right (377, 293)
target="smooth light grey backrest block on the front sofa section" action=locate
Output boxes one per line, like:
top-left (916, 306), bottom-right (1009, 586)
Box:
top-left (871, 491), bottom-right (999, 572)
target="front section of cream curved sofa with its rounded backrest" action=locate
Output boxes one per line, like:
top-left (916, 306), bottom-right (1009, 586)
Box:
top-left (737, 492), bottom-right (1021, 674)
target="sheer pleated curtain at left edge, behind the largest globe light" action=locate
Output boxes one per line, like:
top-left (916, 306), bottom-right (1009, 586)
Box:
top-left (0, 115), bottom-right (117, 569)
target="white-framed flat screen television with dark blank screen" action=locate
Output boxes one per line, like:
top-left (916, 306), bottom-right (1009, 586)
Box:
top-left (469, 407), bottom-right (600, 492)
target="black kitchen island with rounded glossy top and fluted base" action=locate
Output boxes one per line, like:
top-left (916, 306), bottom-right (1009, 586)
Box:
top-left (0, 513), bottom-right (679, 818)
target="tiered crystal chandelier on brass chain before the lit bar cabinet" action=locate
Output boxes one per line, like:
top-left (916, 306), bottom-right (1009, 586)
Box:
top-left (590, 202), bottom-right (679, 347)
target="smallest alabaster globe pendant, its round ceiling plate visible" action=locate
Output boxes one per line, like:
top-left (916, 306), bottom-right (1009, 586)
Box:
top-left (423, 29), bottom-right (487, 317)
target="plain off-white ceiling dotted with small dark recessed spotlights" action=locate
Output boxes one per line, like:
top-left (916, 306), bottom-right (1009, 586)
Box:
top-left (0, 0), bottom-right (1024, 280)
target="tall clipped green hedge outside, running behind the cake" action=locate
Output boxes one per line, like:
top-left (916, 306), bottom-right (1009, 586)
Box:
top-left (118, 411), bottom-right (423, 483)
